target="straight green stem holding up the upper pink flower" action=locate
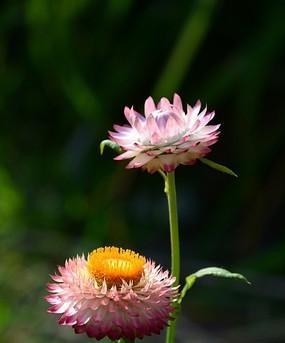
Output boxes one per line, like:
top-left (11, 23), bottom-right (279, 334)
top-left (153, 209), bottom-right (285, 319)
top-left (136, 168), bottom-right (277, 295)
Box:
top-left (165, 171), bottom-right (180, 343)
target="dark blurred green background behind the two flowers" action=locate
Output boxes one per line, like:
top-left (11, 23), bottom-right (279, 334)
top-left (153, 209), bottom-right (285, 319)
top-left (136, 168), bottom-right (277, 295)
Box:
top-left (0, 0), bottom-right (285, 343)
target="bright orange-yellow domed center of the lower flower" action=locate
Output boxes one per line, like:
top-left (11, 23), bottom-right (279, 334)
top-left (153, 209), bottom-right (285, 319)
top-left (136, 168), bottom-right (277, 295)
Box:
top-left (87, 247), bottom-right (146, 286)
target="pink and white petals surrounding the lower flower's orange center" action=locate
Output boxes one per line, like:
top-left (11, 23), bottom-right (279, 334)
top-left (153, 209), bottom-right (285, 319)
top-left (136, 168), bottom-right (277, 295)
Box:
top-left (47, 251), bottom-right (178, 340)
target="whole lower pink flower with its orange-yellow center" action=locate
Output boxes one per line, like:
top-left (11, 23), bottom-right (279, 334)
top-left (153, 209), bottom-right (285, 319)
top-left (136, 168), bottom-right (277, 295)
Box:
top-left (45, 247), bottom-right (178, 340)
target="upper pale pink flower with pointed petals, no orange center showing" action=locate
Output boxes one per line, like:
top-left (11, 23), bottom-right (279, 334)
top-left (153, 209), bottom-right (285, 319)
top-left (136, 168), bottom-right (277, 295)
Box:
top-left (109, 94), bottom-right (220, 173)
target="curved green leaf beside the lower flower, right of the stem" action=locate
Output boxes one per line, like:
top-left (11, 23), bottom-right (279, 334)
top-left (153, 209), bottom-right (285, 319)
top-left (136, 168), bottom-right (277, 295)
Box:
top-left (177, 267), bottom-right (250, 304)
